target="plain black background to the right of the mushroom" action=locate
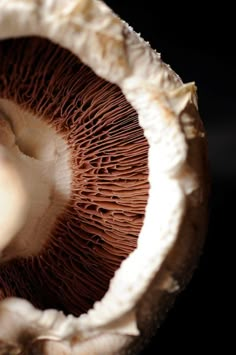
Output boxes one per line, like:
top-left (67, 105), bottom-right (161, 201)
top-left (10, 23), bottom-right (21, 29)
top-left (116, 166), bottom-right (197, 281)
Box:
top-left (106, 0), bottom-right (236, 355)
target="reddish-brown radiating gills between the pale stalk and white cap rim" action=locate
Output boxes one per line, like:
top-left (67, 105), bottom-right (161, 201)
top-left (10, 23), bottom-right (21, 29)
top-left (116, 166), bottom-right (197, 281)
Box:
top-left (0, 37), bottom-right (149, 315)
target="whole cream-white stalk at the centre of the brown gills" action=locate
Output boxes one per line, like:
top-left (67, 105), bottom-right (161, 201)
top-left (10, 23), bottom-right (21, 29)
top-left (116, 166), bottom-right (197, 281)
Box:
top-left (0, 99), bottom-right (71, 262)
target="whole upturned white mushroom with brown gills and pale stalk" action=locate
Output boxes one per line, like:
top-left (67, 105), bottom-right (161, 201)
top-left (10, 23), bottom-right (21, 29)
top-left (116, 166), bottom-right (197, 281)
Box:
top-left (0, 0), bottom-right (208, 355)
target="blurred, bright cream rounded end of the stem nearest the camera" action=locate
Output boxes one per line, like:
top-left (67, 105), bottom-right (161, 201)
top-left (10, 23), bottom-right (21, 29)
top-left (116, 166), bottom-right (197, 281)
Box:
top-left (0, 144), bottom-right (29, 261)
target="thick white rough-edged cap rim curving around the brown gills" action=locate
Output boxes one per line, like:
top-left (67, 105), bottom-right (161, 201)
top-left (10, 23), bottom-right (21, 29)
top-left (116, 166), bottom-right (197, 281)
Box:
top-left (0, 0), bottom-right (208, 355)
